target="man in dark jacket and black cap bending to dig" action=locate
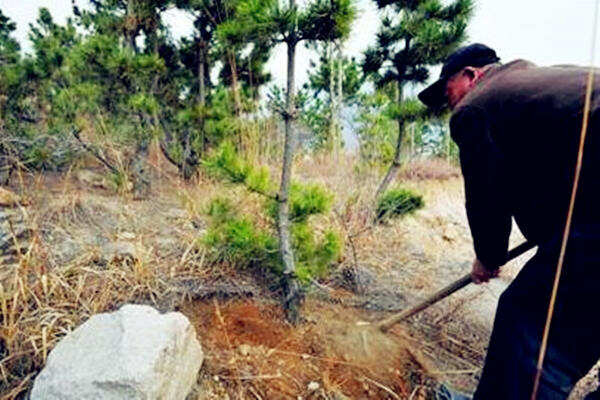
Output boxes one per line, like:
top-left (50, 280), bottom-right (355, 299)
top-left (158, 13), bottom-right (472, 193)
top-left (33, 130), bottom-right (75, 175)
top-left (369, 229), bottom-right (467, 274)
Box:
top-left (419, 44), bottom-right (600, 400)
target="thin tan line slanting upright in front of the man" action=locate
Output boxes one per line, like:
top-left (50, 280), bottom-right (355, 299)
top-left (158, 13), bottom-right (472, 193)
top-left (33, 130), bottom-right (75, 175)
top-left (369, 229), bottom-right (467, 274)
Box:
top-left (531, 0), bottom-right (600, 400)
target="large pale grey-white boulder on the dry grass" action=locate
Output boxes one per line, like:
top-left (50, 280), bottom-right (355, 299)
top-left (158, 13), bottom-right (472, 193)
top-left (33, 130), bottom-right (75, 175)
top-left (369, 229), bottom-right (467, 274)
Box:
top-left (31, 305), bottom-right (204, 400)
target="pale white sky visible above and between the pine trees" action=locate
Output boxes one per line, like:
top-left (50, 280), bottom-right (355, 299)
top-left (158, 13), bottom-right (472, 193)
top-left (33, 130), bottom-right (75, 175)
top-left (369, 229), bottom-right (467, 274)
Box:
top-left (0, 0), bottom-right (600, 90)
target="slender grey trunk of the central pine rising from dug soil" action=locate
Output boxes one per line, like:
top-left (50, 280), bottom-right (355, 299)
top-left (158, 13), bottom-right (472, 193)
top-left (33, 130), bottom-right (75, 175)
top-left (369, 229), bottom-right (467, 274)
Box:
top-left (277, 32), bottom-right (302, 323)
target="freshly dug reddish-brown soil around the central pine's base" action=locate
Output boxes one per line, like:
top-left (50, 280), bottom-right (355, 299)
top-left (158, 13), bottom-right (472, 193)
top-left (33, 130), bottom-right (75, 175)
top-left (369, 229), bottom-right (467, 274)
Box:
top-left (181, 301), bottom-right (427, 399)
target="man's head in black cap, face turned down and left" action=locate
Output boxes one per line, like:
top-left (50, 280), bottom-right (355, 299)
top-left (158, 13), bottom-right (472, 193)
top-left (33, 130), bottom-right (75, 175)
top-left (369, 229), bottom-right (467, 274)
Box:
top-left (419, 43), bottom-right (500, 108)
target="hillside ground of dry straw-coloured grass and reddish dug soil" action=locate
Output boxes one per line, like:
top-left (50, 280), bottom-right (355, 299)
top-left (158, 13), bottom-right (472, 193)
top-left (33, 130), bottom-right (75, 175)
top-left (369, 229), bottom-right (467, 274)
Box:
top-left (0, 151), bottom-right (592, 399)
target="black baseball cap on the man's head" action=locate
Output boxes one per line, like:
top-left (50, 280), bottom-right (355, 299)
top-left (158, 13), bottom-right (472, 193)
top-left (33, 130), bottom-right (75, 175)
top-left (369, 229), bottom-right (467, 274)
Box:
top-left (419, 43), bottom-right (500, 108)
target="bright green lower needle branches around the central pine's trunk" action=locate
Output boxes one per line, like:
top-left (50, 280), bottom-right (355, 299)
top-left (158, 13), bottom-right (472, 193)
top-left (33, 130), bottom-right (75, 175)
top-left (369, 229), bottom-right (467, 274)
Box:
top-left (203, 142), bottom-right (342, 283)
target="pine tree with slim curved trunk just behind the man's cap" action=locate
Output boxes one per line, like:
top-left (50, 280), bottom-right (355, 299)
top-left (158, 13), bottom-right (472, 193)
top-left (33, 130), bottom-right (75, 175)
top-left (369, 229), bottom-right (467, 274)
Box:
top-left (363, 0), bottom-right (473, 196)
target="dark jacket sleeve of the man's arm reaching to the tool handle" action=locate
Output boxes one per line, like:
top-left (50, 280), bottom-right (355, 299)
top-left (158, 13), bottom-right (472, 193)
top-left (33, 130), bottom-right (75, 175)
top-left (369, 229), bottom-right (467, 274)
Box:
top-left (450, 107), bottom-right (512, 270)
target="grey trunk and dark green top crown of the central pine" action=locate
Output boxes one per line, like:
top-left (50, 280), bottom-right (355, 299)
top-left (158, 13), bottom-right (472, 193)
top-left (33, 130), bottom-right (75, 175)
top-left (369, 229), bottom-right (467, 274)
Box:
top-left (219, 0), bottom-right (355, 322)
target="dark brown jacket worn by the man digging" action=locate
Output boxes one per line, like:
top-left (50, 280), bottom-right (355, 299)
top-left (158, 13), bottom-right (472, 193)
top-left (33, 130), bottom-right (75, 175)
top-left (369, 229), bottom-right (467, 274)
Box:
top-left (450, 60), bottom-right (600, 268)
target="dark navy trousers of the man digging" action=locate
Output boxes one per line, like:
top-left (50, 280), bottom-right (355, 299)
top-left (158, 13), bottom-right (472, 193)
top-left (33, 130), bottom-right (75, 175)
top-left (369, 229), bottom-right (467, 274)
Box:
top-left (474, 234), bottom-right (600, 400)
